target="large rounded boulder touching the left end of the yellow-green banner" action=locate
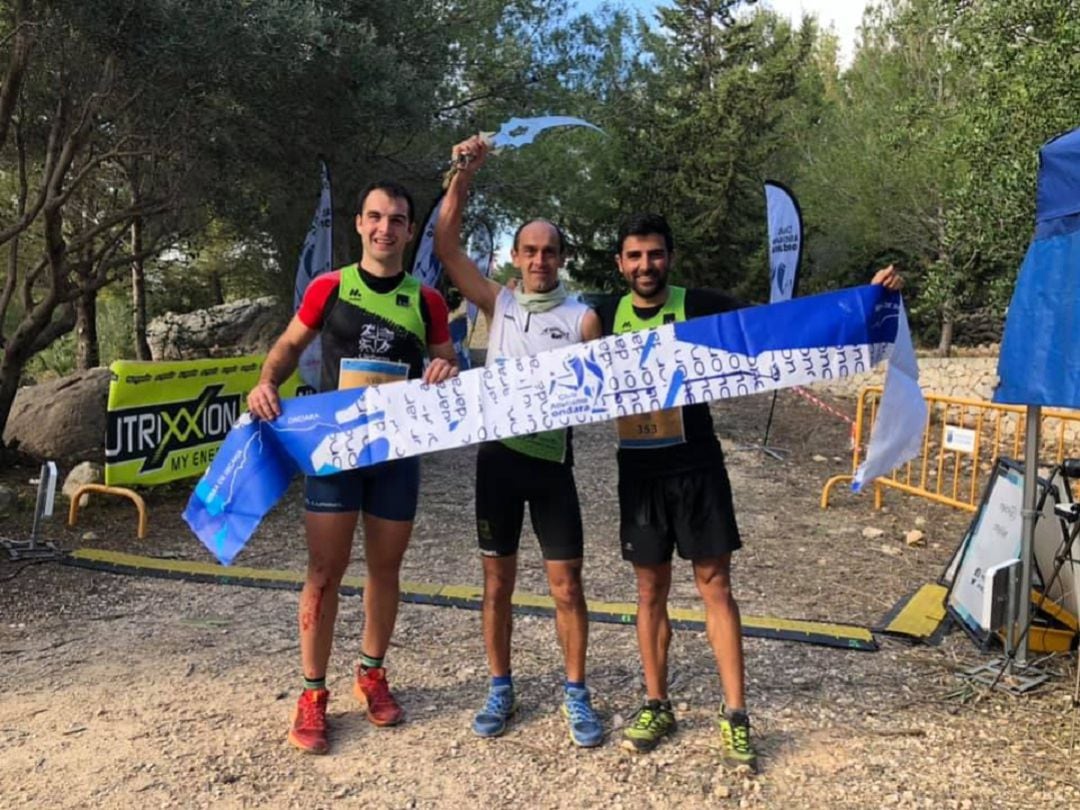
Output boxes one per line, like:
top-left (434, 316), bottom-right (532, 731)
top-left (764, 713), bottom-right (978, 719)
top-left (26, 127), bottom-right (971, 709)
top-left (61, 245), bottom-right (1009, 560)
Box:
top-left (3, 368), bottom-right (111, 463)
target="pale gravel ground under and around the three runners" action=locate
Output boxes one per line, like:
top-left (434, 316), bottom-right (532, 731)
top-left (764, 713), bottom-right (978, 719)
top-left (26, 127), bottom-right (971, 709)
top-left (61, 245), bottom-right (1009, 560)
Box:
top-left (0, 393), bottom-right (1080, 808)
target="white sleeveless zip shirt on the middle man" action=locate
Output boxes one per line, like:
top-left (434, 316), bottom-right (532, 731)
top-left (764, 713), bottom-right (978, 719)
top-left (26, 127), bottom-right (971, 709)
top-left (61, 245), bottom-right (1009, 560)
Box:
top-left (486, 287), bottom-right (589, 365)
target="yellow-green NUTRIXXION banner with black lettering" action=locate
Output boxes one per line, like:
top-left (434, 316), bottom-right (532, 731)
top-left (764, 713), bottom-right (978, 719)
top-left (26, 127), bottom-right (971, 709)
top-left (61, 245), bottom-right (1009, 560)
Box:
top-left (105, 354), bottom-right (302, 486)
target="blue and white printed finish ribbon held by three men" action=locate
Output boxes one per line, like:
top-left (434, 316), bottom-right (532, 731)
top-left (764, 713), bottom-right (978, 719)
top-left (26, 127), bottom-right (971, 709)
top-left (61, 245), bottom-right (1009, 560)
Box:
top-left (184, 286), bottom-right (927, 565)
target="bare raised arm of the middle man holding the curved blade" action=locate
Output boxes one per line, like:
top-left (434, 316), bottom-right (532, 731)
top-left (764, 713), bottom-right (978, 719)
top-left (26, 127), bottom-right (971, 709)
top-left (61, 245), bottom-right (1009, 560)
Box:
top-left (435, 136), bottom-right (500, 318)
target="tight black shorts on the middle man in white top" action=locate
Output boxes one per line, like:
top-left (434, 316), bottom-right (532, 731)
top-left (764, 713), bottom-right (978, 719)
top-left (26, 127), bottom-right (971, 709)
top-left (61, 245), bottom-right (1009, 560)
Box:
top-left (476, 442), bottom-right (584, 559)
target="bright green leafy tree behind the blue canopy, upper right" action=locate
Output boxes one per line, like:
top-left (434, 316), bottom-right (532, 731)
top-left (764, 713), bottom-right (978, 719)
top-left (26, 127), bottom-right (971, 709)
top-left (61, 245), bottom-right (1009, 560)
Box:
top-left (797, 0), bottom-right (1080, 352)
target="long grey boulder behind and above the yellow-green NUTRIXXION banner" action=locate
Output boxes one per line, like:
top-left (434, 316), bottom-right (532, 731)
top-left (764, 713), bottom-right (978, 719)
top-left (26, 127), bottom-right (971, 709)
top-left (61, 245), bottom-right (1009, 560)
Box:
top-left (146, 296), bottom-right (291, 360)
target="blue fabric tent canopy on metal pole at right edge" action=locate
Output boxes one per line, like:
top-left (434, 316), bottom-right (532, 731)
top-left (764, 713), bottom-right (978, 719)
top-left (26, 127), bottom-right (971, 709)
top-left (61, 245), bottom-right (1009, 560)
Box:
top-left (994, 129), bottom-right (1080, 408)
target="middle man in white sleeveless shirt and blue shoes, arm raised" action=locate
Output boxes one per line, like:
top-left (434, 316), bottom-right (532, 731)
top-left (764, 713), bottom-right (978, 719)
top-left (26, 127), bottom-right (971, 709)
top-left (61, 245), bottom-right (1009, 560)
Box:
top-left (435, 137), bottom-right (604, 747)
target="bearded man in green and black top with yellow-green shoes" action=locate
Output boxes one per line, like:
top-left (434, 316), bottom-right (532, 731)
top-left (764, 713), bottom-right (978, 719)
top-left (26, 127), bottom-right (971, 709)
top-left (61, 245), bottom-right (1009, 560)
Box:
top-left (599, 214), bottom-right (901, 769)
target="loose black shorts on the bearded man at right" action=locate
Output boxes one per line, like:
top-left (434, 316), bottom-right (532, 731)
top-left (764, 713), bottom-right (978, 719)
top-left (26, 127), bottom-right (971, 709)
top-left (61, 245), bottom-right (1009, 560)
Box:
top-left (619, 461), bottom-right (742, 565)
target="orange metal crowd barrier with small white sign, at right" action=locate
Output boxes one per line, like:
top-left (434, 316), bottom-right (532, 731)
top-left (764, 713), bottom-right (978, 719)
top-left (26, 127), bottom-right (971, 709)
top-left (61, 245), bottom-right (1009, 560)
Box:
top-left (821, 386), bottom-right (1080, 512)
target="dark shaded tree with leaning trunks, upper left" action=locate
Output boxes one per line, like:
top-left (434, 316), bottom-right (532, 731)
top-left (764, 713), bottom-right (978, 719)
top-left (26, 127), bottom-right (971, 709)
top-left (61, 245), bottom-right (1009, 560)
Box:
top-left (0, 0), bottom-right (587, 438)
